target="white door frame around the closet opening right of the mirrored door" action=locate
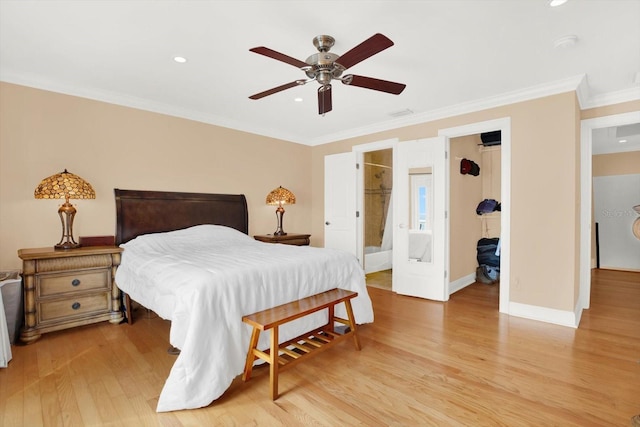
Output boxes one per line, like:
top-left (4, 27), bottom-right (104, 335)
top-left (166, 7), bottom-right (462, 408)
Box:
top-left (438, 117), bottom-right (511, 314)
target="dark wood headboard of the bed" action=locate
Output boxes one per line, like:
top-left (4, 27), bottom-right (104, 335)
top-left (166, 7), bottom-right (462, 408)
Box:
top-left (114, 188), bottom-right (249, 245)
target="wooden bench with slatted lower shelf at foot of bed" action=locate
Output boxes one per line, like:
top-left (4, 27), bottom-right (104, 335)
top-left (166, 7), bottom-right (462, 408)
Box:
top-left (242, 288), bottom-right (360, 400)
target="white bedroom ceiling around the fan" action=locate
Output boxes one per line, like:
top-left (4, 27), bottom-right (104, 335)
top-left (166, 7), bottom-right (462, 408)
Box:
top-left (0, 0), bottom-right (640, 145)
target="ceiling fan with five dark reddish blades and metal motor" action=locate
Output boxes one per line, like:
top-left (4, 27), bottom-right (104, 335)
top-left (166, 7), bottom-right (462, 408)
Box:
top-left (249, 33), bottom-right (406, 114)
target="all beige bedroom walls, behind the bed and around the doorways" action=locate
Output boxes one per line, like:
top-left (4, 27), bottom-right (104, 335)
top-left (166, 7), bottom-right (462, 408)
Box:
top-left (0, 83), bottom-right (640, 311)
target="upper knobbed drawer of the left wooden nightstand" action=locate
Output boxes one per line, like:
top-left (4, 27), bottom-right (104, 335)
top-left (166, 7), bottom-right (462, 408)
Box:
top-left (36, 269), bottom-right (111, 297)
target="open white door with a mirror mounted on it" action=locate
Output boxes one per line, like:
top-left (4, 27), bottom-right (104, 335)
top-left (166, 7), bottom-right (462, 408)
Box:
top-left (392, 137), bottom-right (449, 301)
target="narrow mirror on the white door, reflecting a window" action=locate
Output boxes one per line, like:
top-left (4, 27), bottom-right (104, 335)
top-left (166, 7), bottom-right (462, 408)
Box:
top-left (409, 167), bottom-right (433, 263)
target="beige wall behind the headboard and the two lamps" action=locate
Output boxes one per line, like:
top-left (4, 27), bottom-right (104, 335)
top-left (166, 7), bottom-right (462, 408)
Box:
top-left (0, 83), bottom-right (313, 270)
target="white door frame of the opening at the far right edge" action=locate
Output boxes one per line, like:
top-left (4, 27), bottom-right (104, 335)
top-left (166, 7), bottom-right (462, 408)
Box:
top-left (576, 111), bottom-right (640, 310)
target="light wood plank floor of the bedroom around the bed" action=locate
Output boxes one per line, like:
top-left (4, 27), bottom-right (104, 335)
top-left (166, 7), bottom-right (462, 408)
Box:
top-left (0, 270), bottom-right (640, 427)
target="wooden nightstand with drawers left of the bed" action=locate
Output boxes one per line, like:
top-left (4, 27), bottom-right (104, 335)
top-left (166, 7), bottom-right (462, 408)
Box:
top-left (18, 246), bottom-right (123, 343)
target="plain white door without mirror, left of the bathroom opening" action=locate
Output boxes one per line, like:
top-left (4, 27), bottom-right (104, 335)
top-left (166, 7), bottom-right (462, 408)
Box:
top-left (324, 152), bottom-right (357, 255)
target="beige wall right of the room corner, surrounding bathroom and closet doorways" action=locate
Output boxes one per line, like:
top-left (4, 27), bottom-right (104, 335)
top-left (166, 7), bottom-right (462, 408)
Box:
top-left (312, 93), bottom-right (580, 311)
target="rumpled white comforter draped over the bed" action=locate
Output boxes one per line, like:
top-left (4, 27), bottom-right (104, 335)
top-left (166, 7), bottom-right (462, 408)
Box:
top-left (116, 225), bottom-right (373, 412)
